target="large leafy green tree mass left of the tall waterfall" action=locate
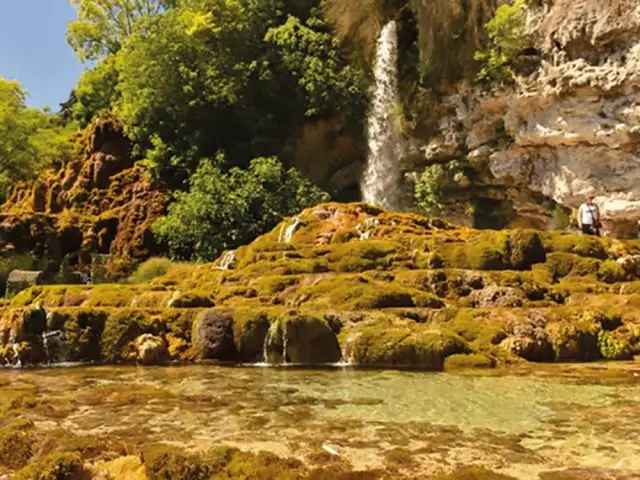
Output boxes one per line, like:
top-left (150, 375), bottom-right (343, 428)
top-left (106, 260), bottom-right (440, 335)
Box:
top-left (117, 0), bottom-right (366, 187)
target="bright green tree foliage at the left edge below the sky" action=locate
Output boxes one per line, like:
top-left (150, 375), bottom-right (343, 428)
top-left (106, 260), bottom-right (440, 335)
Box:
top-left (0, 77), bottom-right (75, 203)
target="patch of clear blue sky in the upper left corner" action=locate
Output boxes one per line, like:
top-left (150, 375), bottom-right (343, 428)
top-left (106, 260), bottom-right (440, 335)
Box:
top-left (0, 0), bottom-right (82, 110)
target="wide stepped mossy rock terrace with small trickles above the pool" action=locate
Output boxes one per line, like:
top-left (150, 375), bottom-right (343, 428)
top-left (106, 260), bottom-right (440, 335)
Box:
top-left (0, 204), bottom-right (640, 370)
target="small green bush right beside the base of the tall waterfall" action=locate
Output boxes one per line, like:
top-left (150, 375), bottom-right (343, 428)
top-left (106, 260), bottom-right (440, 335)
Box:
top-left (414, 160), bottom-right (467, 215)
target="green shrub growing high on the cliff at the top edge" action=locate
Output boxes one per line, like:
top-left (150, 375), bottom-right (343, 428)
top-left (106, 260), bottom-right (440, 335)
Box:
top-left (475, 0), bottom-right (529, 82)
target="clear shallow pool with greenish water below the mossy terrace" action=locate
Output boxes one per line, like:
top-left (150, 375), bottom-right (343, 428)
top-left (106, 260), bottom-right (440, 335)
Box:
top-left (0, 366), bottom-right (640, 479)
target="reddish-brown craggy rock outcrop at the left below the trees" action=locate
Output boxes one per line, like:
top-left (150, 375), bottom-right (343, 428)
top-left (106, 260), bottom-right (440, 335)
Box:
top-left (0, 119), bottom-right (166, 280)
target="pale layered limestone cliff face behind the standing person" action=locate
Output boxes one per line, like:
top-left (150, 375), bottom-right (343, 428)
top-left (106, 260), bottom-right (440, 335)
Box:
top-left (413, 0), bottom-right (640, 237)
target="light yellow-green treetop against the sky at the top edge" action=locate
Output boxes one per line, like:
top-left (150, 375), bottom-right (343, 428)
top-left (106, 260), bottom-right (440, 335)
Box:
top-left (67, 0), bottom-right (176, 61)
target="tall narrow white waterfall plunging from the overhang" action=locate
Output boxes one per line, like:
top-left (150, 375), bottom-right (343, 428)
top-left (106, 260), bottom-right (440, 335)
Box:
top-left (361, 21), bottom-right (404, 210)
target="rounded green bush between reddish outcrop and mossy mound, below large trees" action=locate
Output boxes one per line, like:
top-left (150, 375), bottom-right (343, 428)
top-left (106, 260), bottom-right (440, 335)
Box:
top-left (154, 158), bottom-right (328, 261)
